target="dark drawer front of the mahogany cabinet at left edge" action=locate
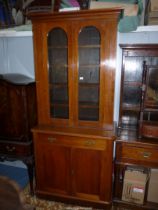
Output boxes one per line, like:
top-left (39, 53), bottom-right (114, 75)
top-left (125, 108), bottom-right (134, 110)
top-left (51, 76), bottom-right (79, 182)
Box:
top-left (0, 142), bottom-right (32, 157)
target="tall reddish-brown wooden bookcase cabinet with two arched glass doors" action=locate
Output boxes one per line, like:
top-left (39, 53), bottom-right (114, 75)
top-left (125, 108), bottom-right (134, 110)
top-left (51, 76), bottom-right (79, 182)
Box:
top-left (29, 9), bottom-right (121, 206)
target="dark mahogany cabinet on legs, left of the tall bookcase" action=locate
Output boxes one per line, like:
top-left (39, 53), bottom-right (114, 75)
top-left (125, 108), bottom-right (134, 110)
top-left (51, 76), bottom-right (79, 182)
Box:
top-left (0, 73), bottom-right (37, 193)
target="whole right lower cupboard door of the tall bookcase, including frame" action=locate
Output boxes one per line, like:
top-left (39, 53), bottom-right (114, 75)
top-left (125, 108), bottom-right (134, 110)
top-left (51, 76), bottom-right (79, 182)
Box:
top-left (72, 140), bottom-right (112, 203)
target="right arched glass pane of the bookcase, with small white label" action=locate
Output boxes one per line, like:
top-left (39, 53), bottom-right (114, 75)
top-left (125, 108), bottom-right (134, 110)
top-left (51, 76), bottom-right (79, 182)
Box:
top-left (78, 26), bottom-right (100, 121)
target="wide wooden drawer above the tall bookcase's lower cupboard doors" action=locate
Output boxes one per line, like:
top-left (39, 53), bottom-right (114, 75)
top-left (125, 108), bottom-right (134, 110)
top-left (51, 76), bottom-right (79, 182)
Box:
top-left (34, 133), bottom-right (109, 150)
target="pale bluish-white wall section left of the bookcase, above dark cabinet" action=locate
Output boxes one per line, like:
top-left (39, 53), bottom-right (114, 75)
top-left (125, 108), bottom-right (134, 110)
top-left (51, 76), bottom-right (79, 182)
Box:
top-left (0, 32), bottom-right (34, 78)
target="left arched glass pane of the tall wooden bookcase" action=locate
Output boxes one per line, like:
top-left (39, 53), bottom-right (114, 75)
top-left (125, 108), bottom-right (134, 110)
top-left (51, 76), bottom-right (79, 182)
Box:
top-left (48, 28), bottom-right (69, 119)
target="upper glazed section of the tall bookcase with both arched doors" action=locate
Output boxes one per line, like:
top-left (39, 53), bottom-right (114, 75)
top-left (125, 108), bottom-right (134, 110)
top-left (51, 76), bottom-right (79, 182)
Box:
top-left (30, 11), bottom-right (119, 129)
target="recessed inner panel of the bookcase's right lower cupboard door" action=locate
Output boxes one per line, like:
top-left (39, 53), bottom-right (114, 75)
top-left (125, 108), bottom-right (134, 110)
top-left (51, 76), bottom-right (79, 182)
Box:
top-left (72, 149), bottom-right (102, 200)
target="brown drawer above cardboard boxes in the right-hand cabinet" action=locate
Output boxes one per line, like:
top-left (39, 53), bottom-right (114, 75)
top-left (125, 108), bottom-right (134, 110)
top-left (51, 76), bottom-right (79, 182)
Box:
top-left (116, 144), bottom-right (158, 164)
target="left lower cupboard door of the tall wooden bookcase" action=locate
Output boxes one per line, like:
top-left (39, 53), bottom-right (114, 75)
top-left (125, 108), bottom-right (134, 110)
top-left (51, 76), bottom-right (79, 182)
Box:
top-left (35, 137), bottom-right (70, 195)
